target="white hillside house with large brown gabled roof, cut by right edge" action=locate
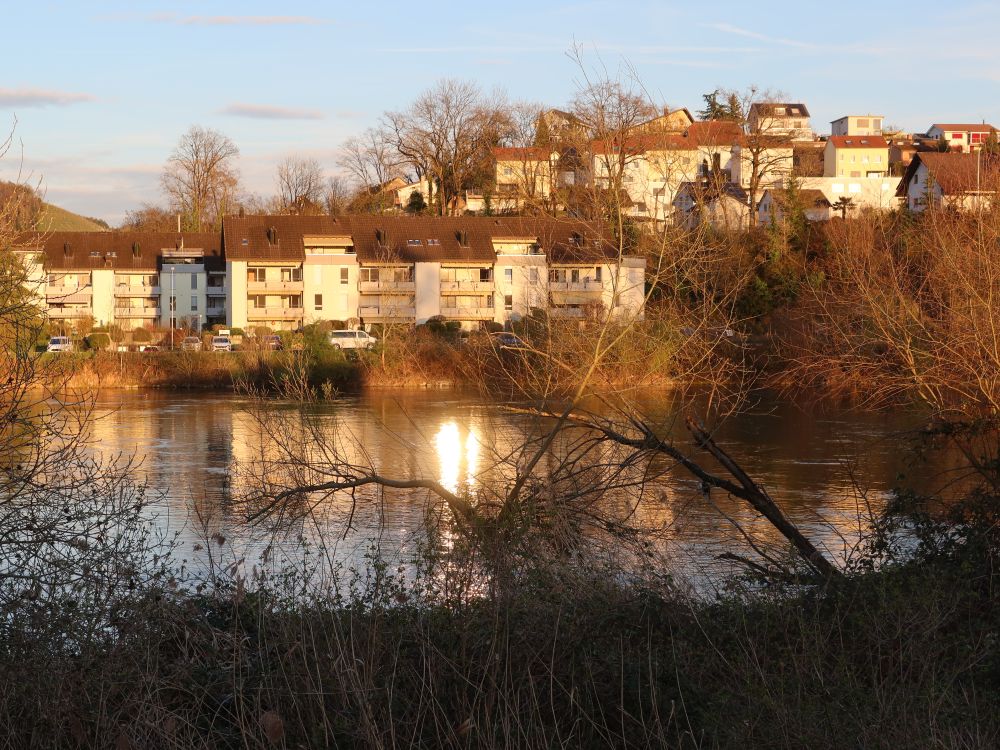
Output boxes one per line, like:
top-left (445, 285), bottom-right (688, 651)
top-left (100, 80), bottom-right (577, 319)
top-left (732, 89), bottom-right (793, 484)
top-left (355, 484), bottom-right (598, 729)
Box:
top-left (896, 151), bottom-right (1000, 212)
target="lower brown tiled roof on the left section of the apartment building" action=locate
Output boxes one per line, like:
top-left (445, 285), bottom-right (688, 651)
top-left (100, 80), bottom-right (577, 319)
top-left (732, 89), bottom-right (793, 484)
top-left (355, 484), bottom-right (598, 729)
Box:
top-left (14, 232), bottom-right (224, 272)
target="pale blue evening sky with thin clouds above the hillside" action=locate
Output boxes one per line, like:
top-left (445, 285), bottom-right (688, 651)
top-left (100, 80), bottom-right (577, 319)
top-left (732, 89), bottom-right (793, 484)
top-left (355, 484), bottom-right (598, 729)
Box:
top-left (0, 0), bottom-right (1000, 224)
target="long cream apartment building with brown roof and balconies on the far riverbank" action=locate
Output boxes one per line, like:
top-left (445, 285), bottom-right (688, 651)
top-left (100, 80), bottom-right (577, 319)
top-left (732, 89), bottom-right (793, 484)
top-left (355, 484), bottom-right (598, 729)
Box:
top-left (20, 215), bottom-right (645, 332)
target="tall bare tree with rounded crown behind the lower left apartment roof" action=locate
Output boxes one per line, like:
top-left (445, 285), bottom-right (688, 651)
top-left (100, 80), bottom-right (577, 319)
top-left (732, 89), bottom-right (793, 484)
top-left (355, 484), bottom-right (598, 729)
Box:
top-left (161, 125), bottom-right (239, 232)
